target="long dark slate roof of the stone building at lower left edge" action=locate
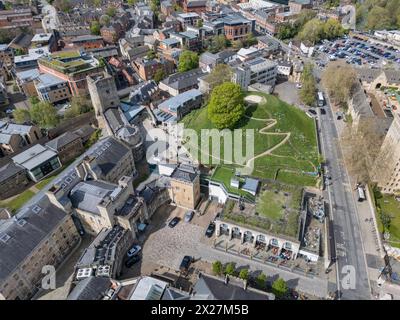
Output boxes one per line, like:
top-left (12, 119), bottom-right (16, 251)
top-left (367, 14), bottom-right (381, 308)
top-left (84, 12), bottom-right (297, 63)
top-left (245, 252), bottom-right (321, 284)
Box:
top-left (0, 196), bottom-right (67, 283)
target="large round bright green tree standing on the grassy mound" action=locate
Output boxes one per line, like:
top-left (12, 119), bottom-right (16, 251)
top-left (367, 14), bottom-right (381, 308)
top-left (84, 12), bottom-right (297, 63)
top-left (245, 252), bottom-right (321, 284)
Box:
top-left (207, 82), bottom-right (245, 129)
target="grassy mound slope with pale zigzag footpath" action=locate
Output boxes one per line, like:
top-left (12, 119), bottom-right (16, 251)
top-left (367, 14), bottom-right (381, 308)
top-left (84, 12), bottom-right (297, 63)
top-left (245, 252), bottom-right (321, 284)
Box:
top-left (182, 92), bottom-right (319, 187)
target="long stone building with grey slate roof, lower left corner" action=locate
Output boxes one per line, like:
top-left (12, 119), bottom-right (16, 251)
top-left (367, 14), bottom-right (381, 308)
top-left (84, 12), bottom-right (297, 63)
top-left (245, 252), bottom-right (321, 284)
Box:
top-left (0, 196), bottom-right (80, 300)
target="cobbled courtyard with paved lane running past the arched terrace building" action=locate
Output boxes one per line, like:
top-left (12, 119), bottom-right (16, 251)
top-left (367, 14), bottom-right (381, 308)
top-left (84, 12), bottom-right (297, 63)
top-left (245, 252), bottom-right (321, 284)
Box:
top-left (134, 208), bottom-right (328, 297)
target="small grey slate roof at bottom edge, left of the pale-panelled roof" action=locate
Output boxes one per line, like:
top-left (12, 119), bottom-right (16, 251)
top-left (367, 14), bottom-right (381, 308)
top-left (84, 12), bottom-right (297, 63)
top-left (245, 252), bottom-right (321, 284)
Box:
top-left (67, 277), bottom-right (111, 300)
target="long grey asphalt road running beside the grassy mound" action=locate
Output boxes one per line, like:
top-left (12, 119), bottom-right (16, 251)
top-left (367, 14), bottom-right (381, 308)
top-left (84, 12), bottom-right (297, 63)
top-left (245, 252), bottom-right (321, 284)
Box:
top-left (319, 88), bottom-right (371, 300)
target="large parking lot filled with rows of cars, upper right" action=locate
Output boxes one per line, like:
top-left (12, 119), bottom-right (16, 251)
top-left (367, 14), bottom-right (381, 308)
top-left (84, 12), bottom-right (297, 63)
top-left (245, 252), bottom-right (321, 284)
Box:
top-left (316, 37), bottom-right (400, 68)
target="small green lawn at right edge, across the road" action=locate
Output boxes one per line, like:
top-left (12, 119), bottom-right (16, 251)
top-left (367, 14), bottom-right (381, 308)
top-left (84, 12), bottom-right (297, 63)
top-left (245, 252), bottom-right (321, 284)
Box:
top-left (375, 191), bottom-right (400, 248)
